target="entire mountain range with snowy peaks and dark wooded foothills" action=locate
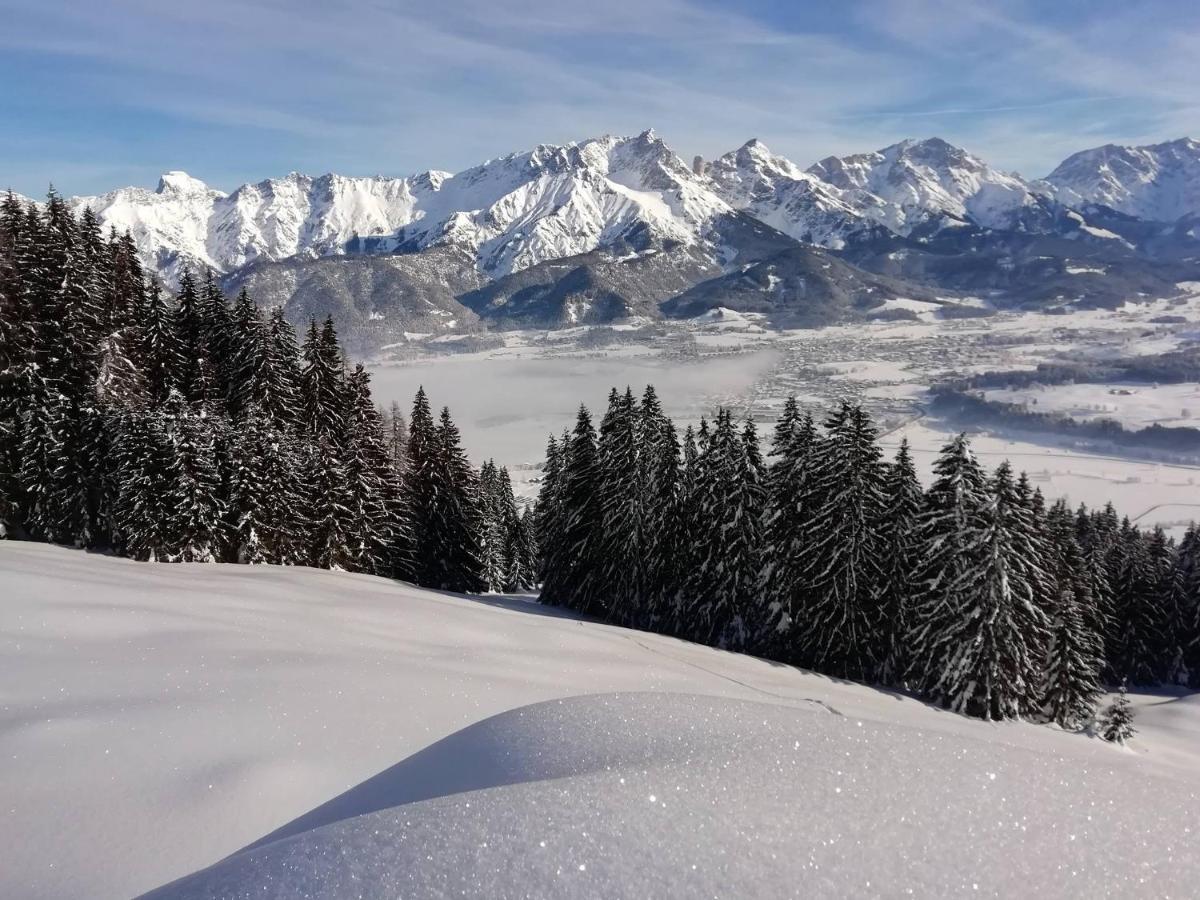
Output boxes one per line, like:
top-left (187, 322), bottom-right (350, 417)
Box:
top-left (23, 131), bottom-right (1200, 347)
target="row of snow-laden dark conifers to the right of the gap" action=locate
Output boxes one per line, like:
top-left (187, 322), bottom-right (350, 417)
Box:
top-left (536, 386), bottom-right (1200, 728)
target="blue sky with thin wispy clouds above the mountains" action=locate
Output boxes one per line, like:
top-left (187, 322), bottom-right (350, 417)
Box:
top-left (0, 0), bottom-right (1200, 194)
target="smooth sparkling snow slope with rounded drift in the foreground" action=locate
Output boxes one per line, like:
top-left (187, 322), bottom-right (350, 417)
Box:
top-left (0, 542), bottom-right (1200, 898)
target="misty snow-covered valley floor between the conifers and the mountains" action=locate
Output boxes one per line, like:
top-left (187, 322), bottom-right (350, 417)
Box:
top-left (372, 303), bottom-right (1200, 535)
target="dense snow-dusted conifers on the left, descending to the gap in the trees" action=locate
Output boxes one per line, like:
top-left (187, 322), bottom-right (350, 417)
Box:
top-left (0, 193), bottom-right (535, 592)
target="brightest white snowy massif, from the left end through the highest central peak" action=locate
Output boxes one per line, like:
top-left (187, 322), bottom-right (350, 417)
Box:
top-left (72, 131), bottom-right (732, 280)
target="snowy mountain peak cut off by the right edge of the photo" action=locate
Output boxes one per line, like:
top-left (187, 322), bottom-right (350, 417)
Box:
top-left (1045, 138), bottom-right (1200, 222)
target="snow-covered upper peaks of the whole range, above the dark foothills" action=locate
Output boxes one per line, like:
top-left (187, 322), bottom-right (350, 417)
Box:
top-left (60, 131), bottom-right (1200, 282)
